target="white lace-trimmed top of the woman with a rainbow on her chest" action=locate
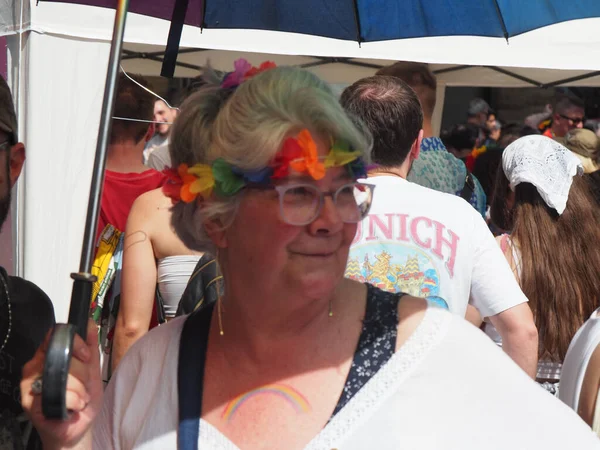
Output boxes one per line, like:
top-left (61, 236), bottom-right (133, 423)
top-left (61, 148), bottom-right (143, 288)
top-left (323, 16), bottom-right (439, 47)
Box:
top-left (94, 307), bottom-right (600, 450)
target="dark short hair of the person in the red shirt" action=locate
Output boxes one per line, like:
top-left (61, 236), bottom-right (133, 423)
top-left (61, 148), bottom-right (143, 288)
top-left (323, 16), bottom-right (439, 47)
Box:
top-left (110, 73), bottom-right (155, 143)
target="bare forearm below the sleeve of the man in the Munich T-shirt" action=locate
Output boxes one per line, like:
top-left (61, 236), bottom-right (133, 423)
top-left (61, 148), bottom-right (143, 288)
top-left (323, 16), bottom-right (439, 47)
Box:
top-left (490, 303), bottom-right (538, 379)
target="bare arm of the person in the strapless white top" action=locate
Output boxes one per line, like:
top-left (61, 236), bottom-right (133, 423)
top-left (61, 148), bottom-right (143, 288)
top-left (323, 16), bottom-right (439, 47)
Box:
top-left (112, 195), bottom-right (157, 372)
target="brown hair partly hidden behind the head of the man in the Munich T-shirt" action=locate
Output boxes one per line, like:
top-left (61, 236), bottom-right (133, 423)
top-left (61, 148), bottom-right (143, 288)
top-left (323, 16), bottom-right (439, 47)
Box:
top-left (375, 61), bottom-right (437, 117)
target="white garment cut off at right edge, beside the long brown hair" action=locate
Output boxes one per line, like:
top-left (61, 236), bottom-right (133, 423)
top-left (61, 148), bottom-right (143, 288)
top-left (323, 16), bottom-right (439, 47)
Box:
top-left (558, 308), bottom-right (600, 411)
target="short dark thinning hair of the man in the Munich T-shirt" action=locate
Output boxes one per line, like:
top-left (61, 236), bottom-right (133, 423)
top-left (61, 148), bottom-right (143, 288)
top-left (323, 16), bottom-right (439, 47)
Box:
top-left (340, 75), bottom-right (423, 167)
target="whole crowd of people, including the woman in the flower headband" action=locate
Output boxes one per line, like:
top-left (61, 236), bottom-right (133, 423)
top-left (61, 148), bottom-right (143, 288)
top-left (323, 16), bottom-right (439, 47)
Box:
top-left (0, 60), bottom-right (600, 449)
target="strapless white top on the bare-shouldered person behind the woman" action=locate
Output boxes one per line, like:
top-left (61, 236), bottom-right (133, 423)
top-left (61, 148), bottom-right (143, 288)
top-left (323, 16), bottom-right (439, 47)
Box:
top-left (157, 255), bottom-right (200, 317)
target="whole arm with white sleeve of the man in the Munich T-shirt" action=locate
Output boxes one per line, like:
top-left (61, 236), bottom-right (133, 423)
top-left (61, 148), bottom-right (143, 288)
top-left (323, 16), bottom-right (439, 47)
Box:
top-left (471, 213), bottom-right (538, 378)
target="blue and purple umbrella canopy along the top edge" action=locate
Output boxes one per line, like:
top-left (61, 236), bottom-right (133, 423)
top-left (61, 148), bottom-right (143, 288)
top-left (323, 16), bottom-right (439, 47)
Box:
top-left (44, 0), bottom-right (600, 42)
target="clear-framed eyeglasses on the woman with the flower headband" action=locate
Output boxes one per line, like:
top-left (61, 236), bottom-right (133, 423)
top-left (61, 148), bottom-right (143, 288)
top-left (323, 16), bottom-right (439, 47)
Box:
top-left (248, 182), bottom-right (375, 226)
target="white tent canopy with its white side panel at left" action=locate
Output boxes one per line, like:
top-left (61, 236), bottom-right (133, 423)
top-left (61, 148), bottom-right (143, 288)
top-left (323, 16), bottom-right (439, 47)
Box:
top-left (0, 0), bottom-right (600, 321)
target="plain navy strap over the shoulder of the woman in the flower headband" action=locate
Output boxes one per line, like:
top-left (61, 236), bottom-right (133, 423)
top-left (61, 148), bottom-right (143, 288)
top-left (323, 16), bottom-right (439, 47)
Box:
top-left (177, 304), bottom-right (214, 450)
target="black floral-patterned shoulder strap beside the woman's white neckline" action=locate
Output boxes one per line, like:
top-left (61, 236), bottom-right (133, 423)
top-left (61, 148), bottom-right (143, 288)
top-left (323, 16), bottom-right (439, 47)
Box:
top-left (332, 284), bottom-right (404, 417)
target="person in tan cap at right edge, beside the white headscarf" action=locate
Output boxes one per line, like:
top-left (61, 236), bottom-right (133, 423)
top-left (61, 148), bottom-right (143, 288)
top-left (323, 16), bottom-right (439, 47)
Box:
top-left (562, 129), bottom-right (600, 204)
